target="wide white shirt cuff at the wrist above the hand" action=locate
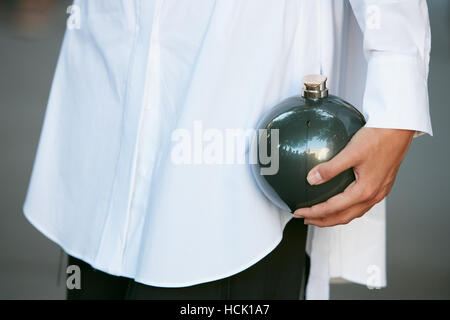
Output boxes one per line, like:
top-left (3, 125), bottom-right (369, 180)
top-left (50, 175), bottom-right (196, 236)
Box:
top-left (362, 52), bottom-right (433, 137)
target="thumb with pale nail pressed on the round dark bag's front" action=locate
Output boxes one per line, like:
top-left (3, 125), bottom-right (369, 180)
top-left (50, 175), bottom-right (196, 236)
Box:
top-left (306, 148), bottom-right (358, 185)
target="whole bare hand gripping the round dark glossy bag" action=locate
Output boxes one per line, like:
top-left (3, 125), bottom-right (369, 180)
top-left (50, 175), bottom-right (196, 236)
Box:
top-left (294, 128), bottom-right (404, 226)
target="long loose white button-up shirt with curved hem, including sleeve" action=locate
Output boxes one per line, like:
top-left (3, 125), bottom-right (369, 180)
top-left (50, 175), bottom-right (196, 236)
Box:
top-left (24, 0), bottom-right (432, 299)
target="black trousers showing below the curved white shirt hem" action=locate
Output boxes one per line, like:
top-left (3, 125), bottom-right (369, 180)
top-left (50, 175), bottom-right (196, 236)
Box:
top-left (67, 218), bottom-right (309, 300)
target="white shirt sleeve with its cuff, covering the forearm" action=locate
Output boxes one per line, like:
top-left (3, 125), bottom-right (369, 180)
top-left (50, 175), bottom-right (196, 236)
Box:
top-left (350, 0), bottom-right (433, 137)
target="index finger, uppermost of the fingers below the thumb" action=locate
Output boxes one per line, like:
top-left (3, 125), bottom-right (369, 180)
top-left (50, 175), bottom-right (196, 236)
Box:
top-left (294, 181), bottom-right (370, 218)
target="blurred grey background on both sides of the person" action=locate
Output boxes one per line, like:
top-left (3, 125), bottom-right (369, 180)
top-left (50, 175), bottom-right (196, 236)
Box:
top-left (0, 0), bottom-right (450, 299)
